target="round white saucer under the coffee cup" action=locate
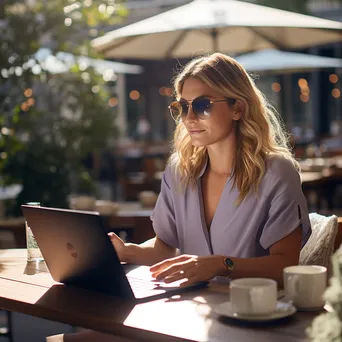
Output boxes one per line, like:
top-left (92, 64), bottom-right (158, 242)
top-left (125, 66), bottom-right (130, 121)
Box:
top-left (214, 301), bottom-right (297, 322)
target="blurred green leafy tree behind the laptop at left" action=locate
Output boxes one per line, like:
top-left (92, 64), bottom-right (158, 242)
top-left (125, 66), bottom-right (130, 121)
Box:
top-left (0, 0), bottom-right (127, 215)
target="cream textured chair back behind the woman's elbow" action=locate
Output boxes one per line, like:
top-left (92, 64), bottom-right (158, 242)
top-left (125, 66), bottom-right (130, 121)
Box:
top-left (299, 213), bottom-right (338, 274)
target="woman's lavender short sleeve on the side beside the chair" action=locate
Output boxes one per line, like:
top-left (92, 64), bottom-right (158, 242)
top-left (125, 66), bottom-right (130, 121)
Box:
top-left (259, 157), bottom-right (311, 249)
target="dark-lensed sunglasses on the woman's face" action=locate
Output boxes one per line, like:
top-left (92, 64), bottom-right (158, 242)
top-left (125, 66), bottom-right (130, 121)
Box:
top-left (169, 97), bottom-right (235, 122)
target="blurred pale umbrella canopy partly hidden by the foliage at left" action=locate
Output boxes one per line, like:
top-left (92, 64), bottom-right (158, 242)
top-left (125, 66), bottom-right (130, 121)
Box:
top-left (33, 48), bottom-right (143, 74)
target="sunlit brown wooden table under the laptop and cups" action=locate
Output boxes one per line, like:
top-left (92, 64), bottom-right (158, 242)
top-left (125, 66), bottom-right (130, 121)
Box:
top-left (0, 249), bottom-right (316, 342)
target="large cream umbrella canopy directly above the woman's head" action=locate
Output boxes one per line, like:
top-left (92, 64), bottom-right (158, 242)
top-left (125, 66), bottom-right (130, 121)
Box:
top-left (92, 0), bottom-right (342, 59)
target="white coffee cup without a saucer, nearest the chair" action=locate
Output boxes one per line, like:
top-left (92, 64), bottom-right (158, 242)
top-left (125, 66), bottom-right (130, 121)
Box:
top-left (283, 265), bottom-right (327, 310)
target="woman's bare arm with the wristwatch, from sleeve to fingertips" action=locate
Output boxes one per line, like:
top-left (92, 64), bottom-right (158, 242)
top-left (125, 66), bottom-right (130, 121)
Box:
top-left (151, 227), bottom-right (301, 286)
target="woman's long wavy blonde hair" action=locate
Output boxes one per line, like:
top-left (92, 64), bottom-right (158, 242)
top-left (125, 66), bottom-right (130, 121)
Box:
top-left (169, 53), bottom-right (299, 204)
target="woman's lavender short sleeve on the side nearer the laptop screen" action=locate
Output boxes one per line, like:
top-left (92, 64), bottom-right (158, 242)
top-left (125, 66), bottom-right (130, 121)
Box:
top-left (151, 166), bottom-right (178, 248)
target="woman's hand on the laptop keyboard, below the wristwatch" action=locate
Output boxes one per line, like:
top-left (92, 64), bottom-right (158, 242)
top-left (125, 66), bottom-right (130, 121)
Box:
top-left (150, 254), bottom-right (224, 286)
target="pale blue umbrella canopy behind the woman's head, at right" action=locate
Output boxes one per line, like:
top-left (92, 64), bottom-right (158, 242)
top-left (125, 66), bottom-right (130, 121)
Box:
top-left (235, 49), bottom-right (342, 73)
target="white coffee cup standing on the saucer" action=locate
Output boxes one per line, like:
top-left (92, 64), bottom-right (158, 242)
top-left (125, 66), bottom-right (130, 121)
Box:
top-left (230, 278), bottom-right (277, 315)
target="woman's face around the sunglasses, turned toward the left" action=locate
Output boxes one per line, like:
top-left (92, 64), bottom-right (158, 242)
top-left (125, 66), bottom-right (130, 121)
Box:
top-left (180, 78), bottom-right (240, 147)
